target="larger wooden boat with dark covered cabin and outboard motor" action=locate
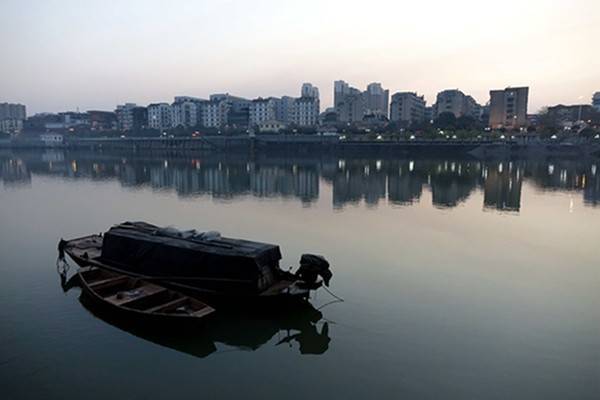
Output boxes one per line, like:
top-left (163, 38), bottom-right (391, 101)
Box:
top-left (59, 222), bottom-right (331, 307)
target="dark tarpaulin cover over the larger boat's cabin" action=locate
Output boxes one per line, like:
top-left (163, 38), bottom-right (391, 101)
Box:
top-left (102, 222), bottom-right (281, 285)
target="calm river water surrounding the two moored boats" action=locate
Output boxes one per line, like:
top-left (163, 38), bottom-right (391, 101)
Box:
top-left (0, 152), bottom-right (600, 399)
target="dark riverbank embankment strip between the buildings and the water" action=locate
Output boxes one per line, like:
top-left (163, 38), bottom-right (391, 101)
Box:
top-left (0, 135), bottom-right (600, 158)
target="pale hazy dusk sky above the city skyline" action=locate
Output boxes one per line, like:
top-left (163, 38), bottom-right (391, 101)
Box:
top-left (0, 0), bottom-right (600, 114)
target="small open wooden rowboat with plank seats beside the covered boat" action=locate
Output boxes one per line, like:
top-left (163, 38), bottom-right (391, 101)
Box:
top-left (78, 267), bottom-right (215, 321)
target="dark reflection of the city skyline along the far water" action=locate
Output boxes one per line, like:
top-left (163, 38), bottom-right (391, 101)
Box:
top-left (0, 152), bottom-right (600, 212)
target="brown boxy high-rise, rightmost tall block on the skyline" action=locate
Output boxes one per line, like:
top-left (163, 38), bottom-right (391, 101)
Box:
top-left (489, 87), bottom-right (529, 129)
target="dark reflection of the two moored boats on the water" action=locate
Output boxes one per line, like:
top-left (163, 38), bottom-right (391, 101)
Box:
top-left (61, 274), bottom-right (331, 358)
